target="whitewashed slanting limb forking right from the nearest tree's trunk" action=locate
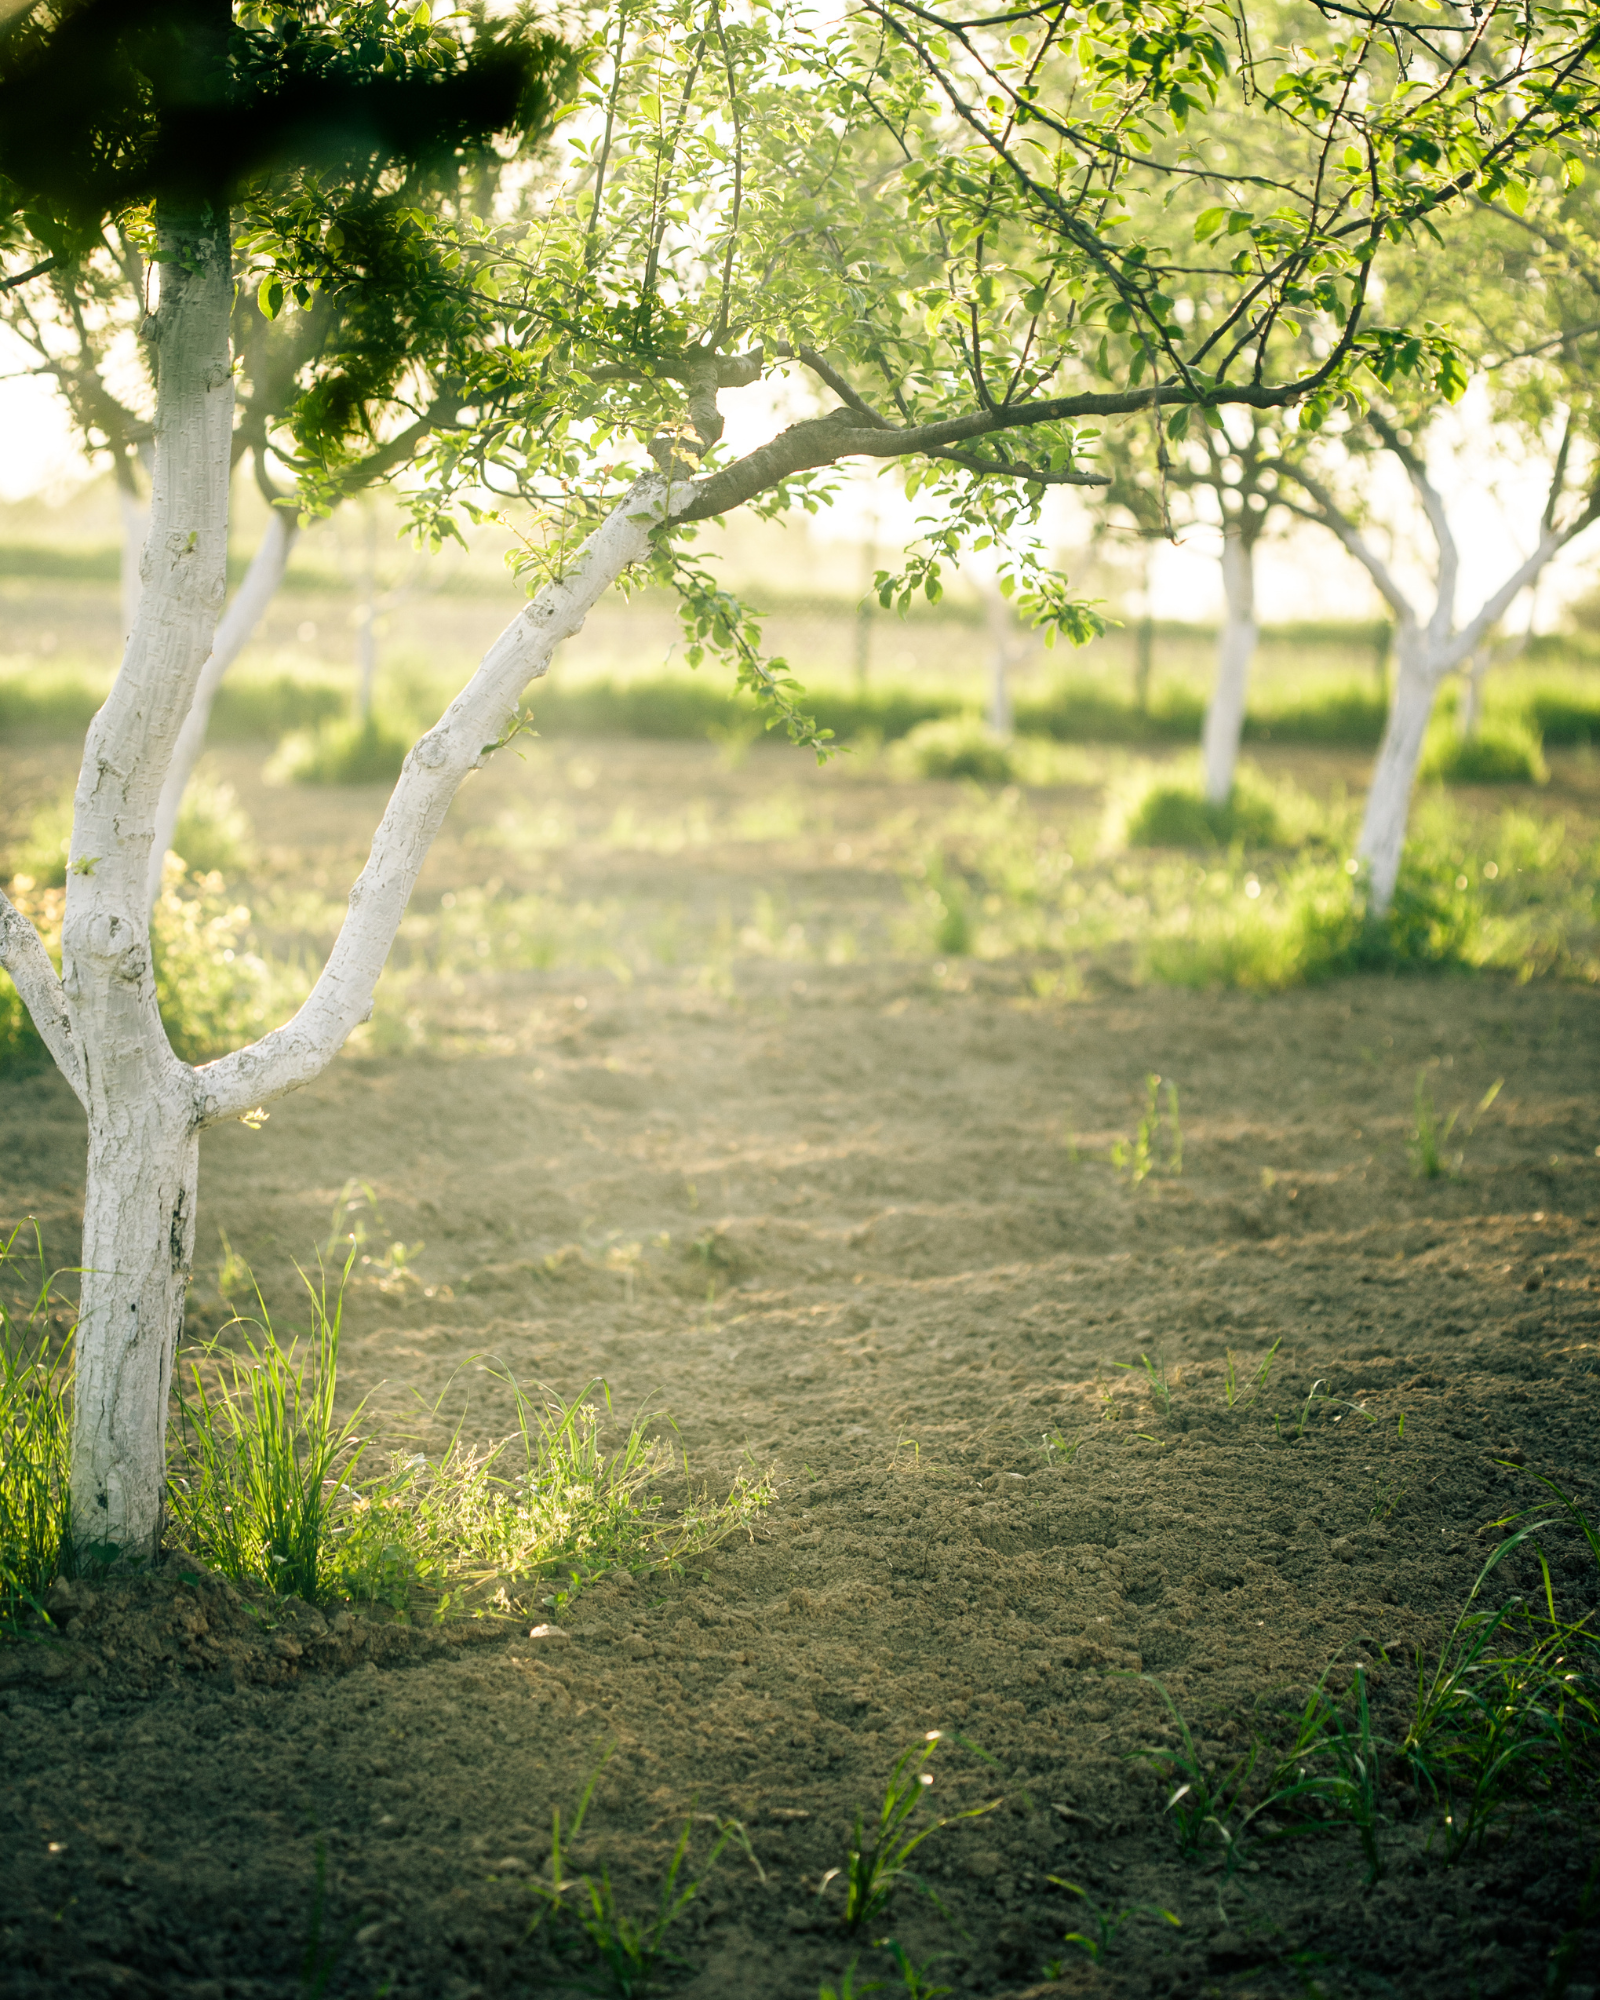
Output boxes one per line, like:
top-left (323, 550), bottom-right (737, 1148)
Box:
top-left (194, 472), bottom-right (680, 1126)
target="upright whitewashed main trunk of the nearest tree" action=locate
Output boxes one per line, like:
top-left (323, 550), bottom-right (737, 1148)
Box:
top-left (62, 216), bottom-right (234, 1556)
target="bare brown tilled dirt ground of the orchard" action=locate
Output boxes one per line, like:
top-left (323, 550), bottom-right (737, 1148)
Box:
top-left (0, 746), bottom-right (1600, 2000)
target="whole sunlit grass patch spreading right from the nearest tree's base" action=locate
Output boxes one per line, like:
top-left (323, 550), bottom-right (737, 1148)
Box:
top-left (170, 1242), bottom-right (770, 1618)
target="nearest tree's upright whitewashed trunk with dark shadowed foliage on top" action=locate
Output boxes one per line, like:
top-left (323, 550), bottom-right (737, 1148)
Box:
top-left (0, 0), bottom-right (566, 1554)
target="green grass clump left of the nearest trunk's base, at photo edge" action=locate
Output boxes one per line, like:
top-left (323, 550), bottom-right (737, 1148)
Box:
top-left (0, 1230), bottom-right (72, 1632)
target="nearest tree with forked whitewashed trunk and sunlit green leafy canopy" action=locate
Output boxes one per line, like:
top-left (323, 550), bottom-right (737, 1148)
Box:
top-left (0, 0), bottom-right (1594, 1550)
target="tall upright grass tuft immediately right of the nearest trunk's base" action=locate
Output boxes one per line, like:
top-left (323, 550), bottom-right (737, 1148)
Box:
top-left (168, 1262), bottom-right (366, 1604)
